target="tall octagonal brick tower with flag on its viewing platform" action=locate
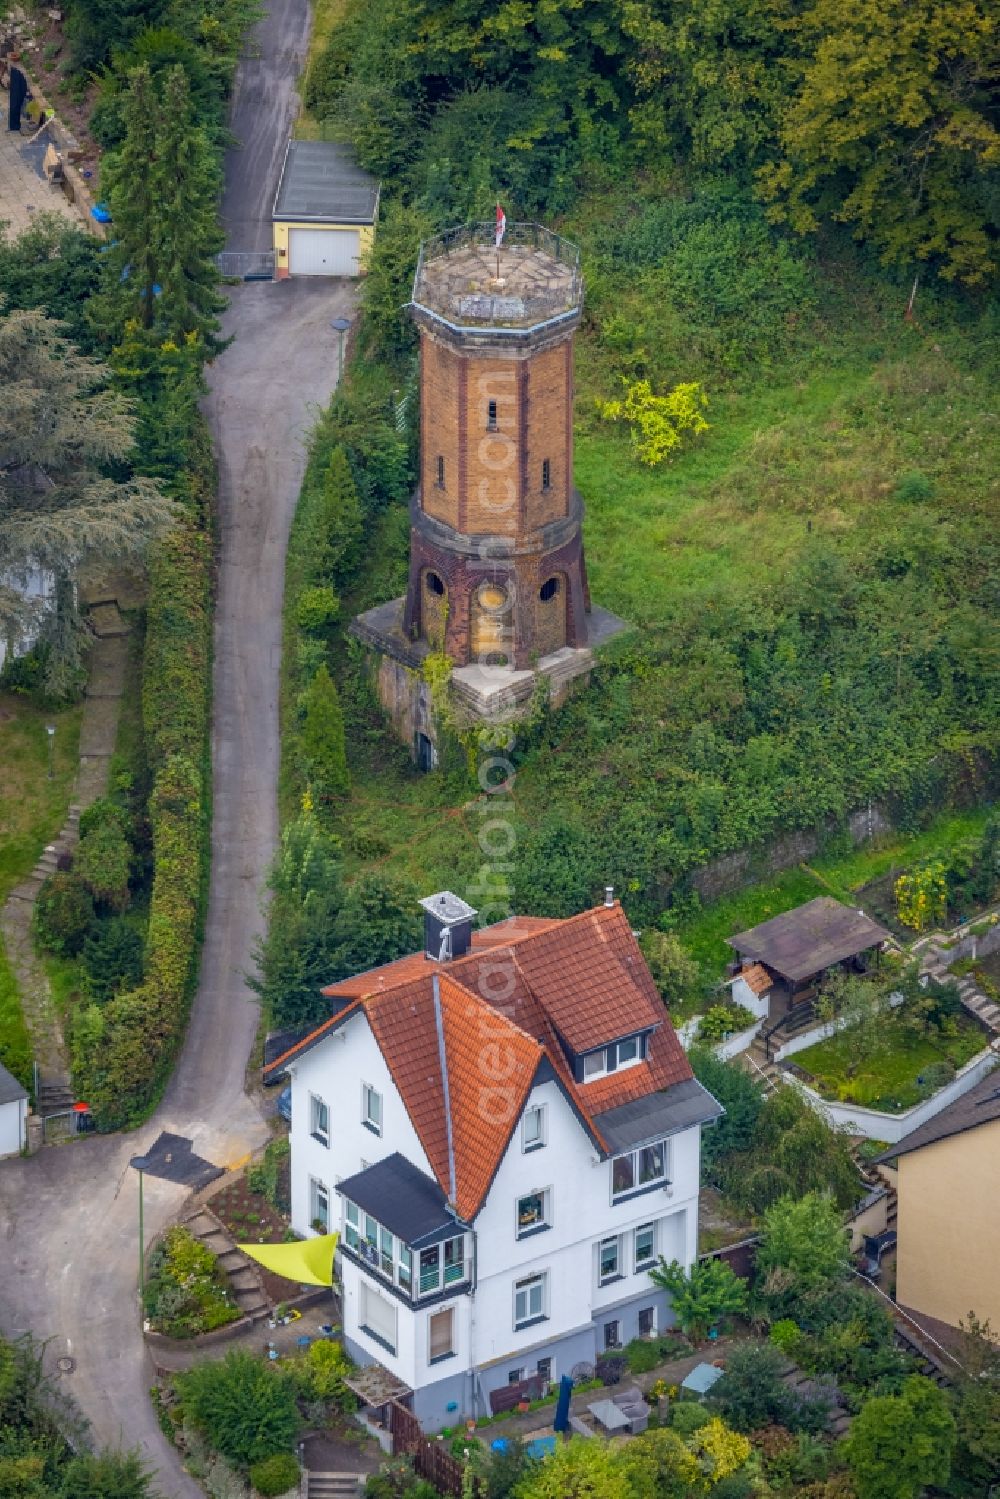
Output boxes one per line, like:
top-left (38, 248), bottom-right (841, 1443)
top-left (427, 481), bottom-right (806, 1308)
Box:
top-left (347, 223), bottom-right (622, 760)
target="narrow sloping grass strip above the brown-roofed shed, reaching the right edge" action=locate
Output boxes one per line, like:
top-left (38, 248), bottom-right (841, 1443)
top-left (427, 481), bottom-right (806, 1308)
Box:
top-left (678, 808), bottom-right (991, 977)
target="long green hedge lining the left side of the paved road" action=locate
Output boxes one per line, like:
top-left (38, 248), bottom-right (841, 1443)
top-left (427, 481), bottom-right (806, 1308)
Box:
top-left (72, 437), bottom-right (214, 1130)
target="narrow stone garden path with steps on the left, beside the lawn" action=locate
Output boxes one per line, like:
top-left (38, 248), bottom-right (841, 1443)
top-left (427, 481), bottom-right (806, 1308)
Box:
top-left (0, 600), bottom-right (129, 1127)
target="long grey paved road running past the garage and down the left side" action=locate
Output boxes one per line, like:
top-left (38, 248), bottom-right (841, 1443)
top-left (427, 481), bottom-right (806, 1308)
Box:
top-left (0, 0), bottom-right (354, 1499)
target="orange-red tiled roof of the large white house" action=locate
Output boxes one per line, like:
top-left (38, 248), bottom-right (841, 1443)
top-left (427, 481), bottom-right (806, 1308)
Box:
top-left (271, 905), bottom-right (693, 1222)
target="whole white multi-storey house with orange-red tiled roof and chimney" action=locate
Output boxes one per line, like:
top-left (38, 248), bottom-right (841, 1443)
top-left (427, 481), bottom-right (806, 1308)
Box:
top-left (268, 892), bottom-right (721, 1429)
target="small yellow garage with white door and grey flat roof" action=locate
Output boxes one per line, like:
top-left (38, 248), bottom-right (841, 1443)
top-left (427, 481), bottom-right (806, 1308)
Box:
top-left (271, 141), bottom-right (379, 280)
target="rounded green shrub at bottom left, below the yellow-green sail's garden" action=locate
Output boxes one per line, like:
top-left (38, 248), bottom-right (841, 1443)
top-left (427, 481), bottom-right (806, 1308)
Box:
top-left (174, 1352), bottom-right (298, 1466)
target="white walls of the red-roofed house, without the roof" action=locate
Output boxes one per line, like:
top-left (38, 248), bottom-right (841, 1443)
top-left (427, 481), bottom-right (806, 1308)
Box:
top-left (289, 1012), bottom-right (700, 1427)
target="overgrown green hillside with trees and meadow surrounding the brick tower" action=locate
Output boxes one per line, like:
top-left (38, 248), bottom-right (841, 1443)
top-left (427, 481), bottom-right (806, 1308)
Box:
top-left (275, 0), bottom-right (1000, 920)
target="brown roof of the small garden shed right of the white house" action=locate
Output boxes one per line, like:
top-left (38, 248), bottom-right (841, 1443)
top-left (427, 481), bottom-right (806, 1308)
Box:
top-left (726, 895), bottom-right (889, 983)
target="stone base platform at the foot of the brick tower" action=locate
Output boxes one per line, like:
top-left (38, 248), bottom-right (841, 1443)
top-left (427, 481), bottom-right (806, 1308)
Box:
top-left (351, 598), bottom-right (630, 769)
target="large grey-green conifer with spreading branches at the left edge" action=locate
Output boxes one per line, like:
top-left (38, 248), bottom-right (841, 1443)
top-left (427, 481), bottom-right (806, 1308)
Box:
top-left (0, 312), bottom-right (172, 696)
